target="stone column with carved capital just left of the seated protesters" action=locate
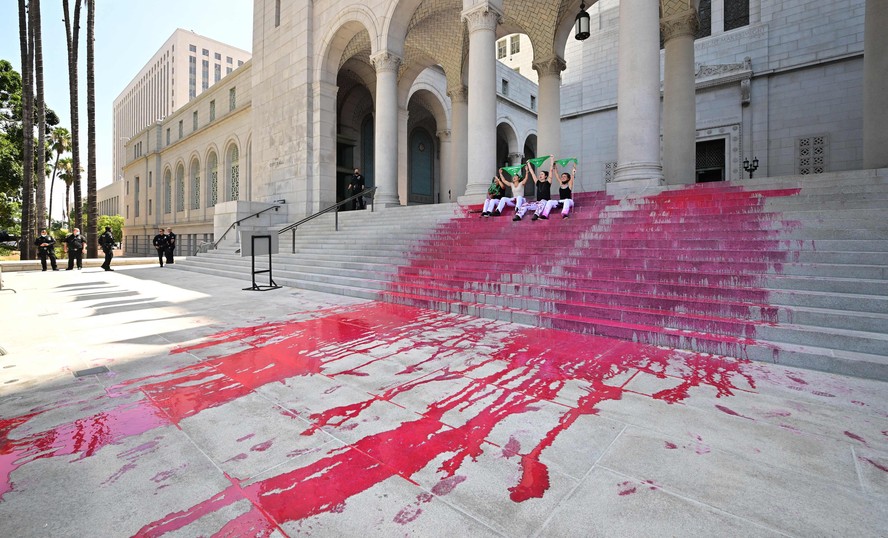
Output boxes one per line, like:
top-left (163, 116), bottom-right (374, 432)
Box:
top-left (459, 5), bottom-right (500, 204)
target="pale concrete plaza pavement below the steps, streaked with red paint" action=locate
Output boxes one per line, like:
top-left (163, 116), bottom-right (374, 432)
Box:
top-left (0, 266), bottom-right (888, 537)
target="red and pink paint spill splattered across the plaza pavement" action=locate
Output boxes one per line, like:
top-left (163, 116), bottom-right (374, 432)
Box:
top-left (0, 303), bottom-right (754, 536)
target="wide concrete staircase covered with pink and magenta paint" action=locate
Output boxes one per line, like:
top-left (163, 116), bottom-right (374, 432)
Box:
top-left (177, 170), bottom-right (888, 380)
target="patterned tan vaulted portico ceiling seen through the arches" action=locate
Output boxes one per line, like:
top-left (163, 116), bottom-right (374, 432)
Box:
top-left (332, 0), bottom-right (588, 89)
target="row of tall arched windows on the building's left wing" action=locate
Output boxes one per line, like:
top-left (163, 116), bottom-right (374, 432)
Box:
top-left (163, 144), bottom-right (241, 214)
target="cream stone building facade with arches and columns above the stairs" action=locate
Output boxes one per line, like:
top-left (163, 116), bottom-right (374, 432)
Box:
top-left (119, 0), bottom-right (888, 252)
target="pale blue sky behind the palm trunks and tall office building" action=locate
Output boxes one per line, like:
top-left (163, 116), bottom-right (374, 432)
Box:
top-left (0, 0), bottom-right (253, 213)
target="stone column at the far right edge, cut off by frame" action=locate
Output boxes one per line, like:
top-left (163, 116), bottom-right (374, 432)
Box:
top-left (863, 0), bottom-right (888, 169)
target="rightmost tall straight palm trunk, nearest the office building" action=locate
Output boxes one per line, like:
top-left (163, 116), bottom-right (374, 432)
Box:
top-left (86, 0), bottom-right (99, 258)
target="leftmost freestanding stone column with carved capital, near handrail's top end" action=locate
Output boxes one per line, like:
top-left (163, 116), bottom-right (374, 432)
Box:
top-left (370, 51), bottom-right (401, 207)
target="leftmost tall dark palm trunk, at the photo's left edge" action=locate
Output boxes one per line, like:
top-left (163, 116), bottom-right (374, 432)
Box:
top-left (19, 0), bottom-right (34, 260)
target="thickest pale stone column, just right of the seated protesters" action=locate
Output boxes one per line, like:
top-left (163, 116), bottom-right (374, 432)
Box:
top-left (607, 0), bottom-right (663, 194)
